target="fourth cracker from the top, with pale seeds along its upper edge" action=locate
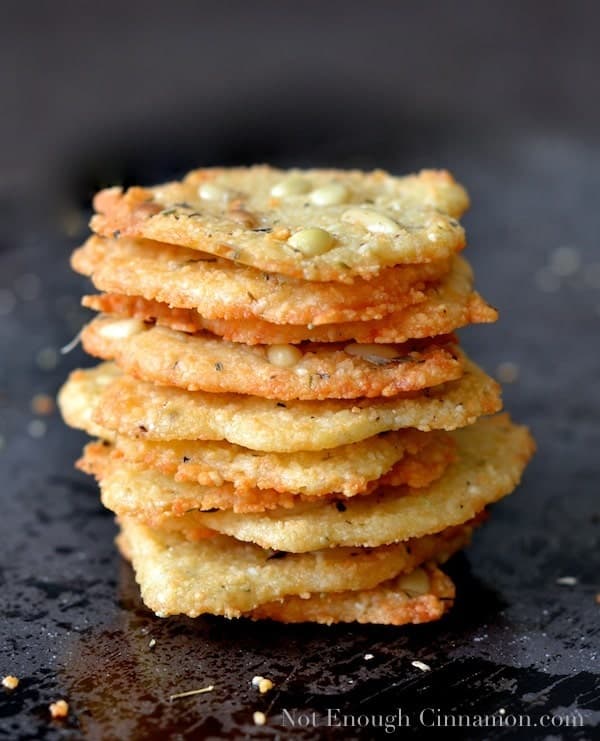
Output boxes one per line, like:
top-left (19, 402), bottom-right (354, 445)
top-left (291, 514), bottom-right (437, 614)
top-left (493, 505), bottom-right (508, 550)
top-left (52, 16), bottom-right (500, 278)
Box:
top-left (81, 316), bottom-right (463, 401)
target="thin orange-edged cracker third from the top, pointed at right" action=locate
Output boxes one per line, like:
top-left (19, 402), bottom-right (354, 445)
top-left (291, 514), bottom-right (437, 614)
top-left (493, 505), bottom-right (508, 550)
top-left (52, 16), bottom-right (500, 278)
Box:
top-left (83, 253), bottom-right (498, 344)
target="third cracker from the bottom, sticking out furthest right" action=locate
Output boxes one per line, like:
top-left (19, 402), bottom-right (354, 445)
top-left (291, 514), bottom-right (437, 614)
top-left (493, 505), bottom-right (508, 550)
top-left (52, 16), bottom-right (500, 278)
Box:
top-left (165, 414), bottom-right (535, 552)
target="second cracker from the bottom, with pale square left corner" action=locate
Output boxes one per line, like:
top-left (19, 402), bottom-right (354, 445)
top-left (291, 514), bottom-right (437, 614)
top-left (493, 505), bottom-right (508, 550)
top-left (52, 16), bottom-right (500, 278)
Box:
top-left (119, 519), bottom-right (472, 617)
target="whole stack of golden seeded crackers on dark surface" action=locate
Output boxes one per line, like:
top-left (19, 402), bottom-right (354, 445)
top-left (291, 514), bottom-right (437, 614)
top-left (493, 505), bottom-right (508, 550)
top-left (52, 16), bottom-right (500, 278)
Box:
top-left (60, 166), bottom-right (534, 625)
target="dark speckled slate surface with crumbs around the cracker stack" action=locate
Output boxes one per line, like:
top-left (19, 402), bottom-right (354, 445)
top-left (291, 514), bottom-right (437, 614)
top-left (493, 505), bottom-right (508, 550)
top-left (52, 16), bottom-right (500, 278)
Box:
top-left (0, 107), bottom-right (600, 739)
